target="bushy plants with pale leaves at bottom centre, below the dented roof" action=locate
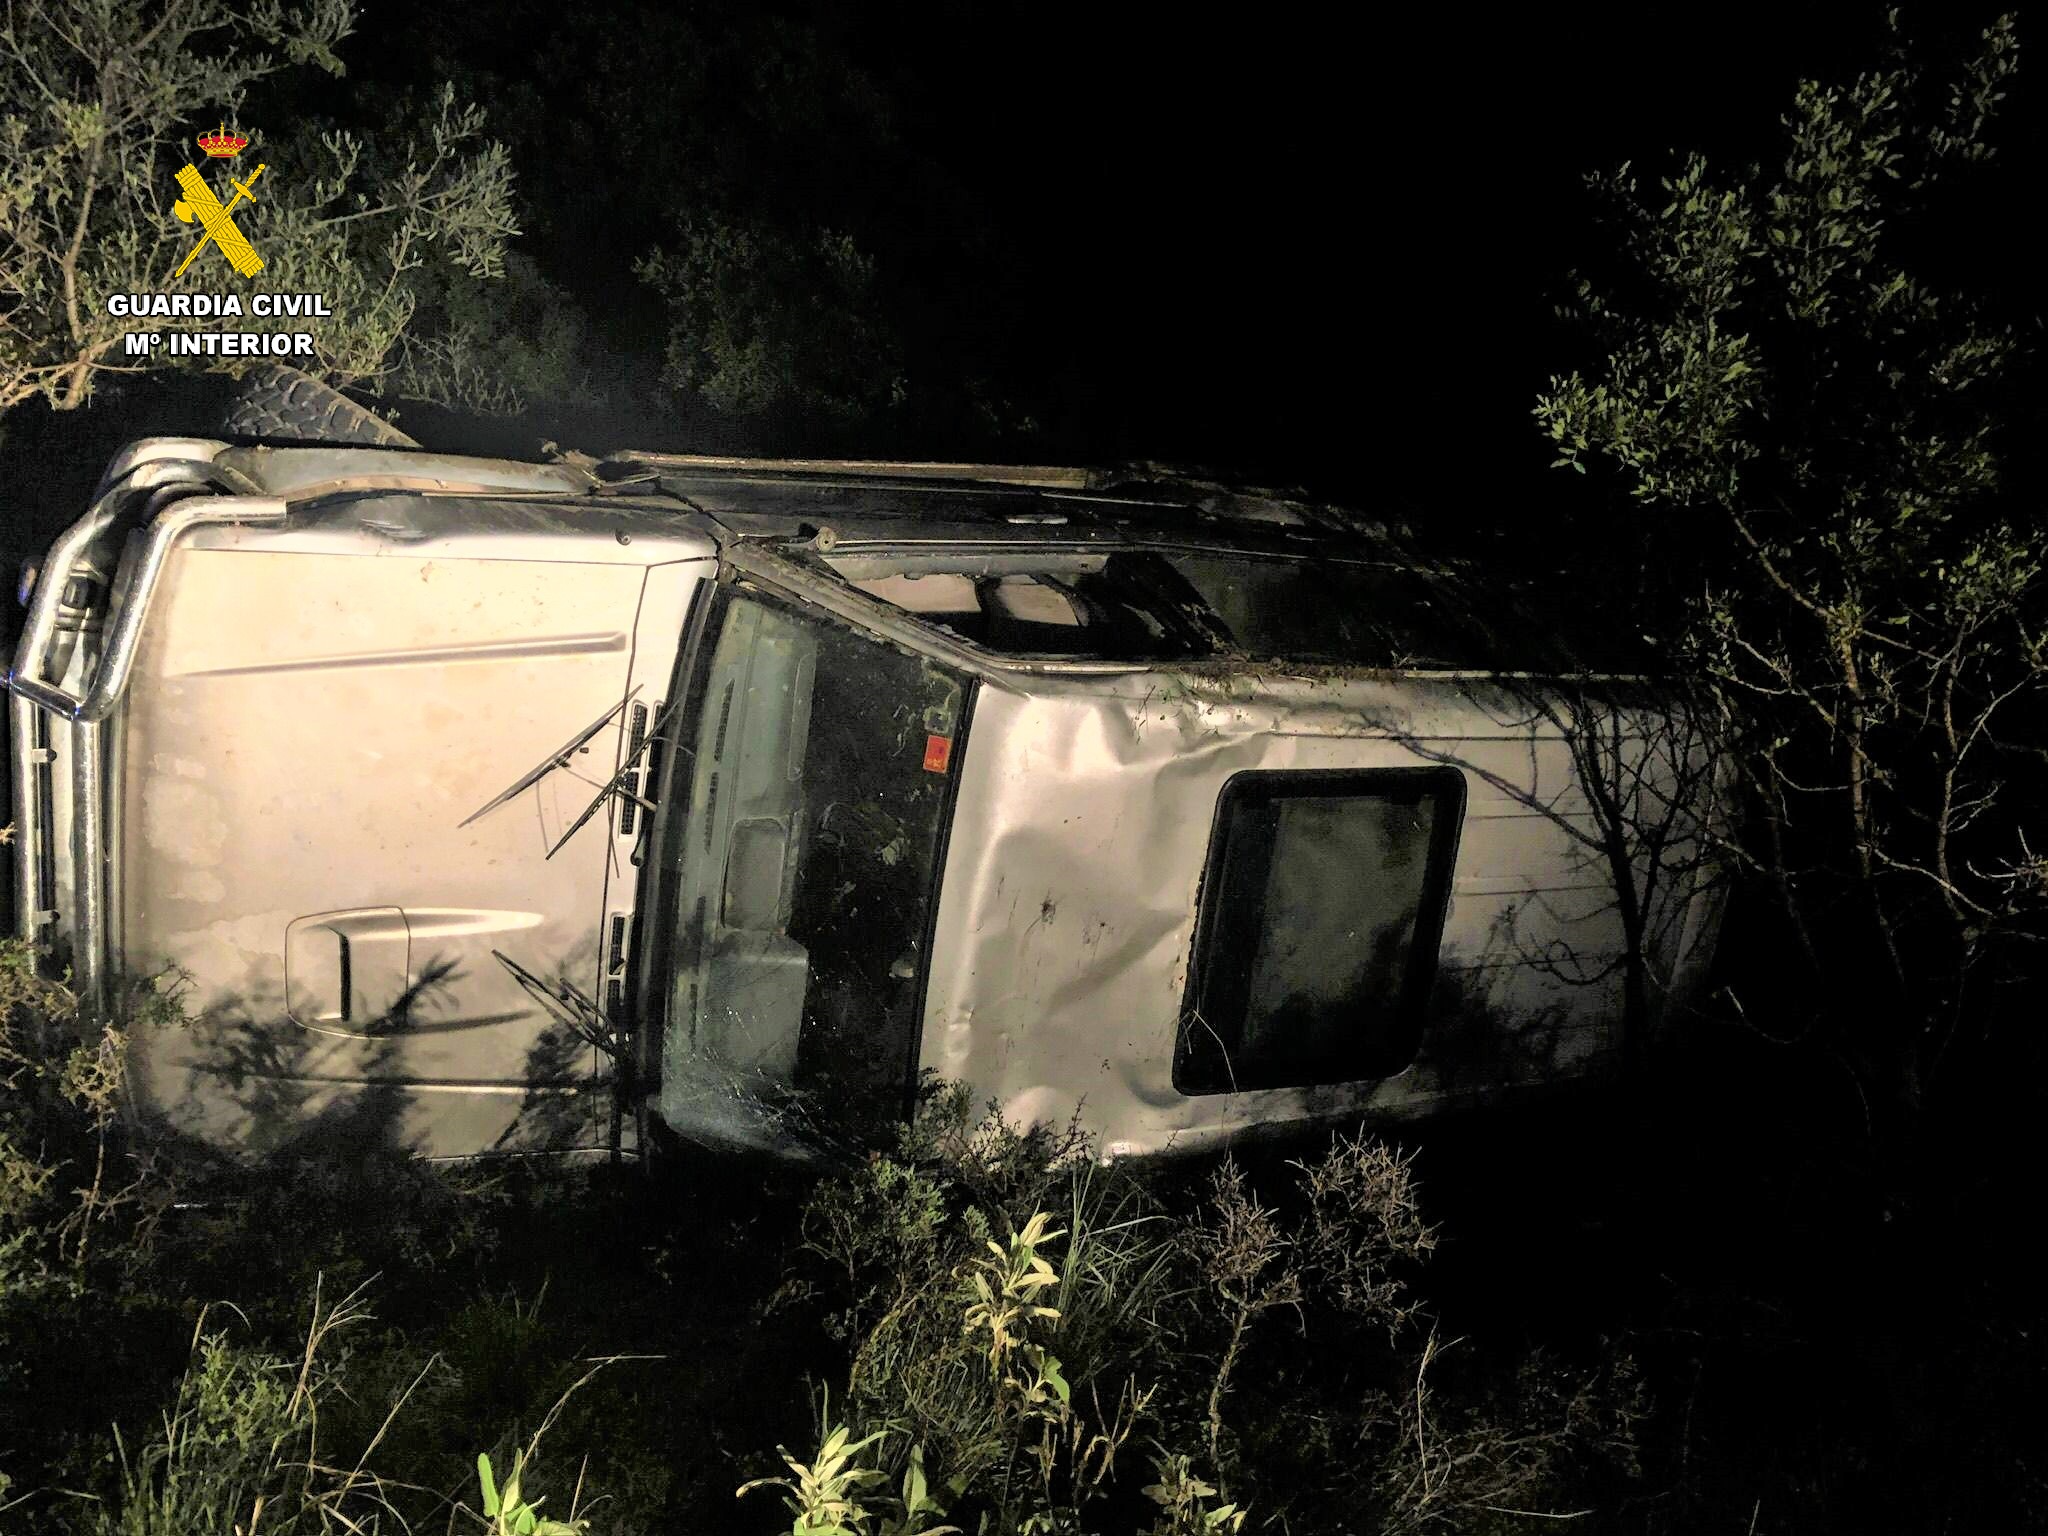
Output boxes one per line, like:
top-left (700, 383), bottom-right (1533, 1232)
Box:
top-left (741, 1094), bottom-right (1647, 1536)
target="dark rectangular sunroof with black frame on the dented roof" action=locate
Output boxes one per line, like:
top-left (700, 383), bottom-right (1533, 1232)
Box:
top-left (1174, 768), bottom-right (1464, 1094)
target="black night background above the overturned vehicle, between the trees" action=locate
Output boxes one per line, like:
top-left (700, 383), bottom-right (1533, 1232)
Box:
top-left (0, 0), bottom-right (2048, 553)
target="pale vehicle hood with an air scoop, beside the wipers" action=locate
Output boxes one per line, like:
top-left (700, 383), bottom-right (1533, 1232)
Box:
top-left (106, 537), bottom-right (696, 1153)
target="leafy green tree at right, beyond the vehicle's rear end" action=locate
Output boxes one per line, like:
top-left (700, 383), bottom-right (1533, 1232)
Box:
top-left (1536, 9), bottom-right (2048, 1133)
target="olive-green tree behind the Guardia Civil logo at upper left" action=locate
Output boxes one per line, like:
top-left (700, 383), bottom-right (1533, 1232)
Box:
top-left (0, 0), bottom-right (518, 410)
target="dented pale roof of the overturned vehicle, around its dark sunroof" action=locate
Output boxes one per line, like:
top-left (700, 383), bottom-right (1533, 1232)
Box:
top-left (924, 674), bottom-right (1710, 1151)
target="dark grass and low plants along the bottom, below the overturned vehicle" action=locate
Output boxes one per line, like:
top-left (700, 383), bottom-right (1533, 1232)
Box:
top-left (0, 954), bottom-right (2048, 1536)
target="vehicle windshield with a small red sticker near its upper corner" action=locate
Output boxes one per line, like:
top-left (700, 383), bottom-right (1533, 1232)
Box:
top-left (659, 594), bottom-right (965, 1145)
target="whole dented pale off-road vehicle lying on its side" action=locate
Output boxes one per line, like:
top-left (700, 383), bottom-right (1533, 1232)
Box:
top-left (8, 438), bottom-right (1718, 1155)
